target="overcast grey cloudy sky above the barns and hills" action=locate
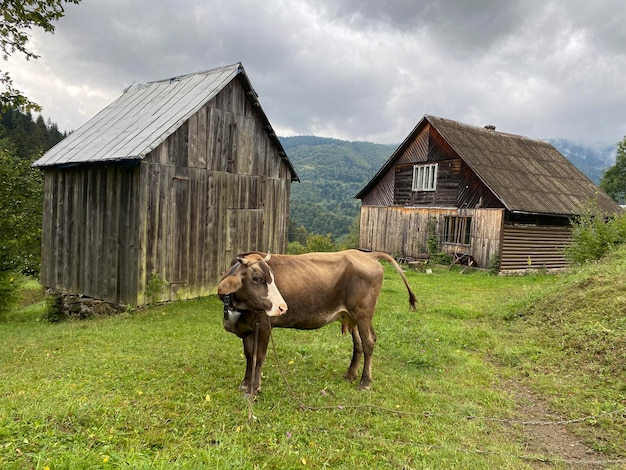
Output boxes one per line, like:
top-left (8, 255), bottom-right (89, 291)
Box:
top-left (6, 0), bottom-right (626, 149)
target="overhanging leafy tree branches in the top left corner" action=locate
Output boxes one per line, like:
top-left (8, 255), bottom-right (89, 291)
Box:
top-left (0, 0), bottom-right (80, 111)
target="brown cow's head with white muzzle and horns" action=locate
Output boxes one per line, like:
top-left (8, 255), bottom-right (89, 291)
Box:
top-left (217, 253), bottom-right (287, 317)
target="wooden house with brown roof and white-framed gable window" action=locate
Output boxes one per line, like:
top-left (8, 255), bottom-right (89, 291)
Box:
top-left (356, 116), bottom-right (621, 272)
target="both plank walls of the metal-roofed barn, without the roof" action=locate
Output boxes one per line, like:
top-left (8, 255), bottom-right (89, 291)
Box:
top-left (41, 70), bottom-right (297, 306)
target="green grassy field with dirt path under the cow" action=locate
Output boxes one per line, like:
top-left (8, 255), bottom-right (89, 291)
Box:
top-left (0, 250), bottom-right (626, 469)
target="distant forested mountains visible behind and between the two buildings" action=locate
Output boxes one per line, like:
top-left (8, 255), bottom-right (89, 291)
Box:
top-left (279, 136), bottom-right (616, 240)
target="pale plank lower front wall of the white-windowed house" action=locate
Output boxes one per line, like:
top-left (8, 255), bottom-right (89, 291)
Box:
top-left (360, 206), bottom-right (504, 268)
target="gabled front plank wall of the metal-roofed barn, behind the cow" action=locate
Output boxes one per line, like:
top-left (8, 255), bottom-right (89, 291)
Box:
top-left (138, 76), bottom-right (291, 303)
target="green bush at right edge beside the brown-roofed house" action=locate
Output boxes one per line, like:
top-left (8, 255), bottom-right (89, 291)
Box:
top-left (564, 202), bottom-right (626, 264)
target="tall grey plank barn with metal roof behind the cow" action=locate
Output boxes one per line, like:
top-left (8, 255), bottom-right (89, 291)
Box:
top-left (34, 63), bottom-right (298, 306)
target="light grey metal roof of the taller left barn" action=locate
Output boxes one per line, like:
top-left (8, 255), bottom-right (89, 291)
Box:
top-left (33, 63), bottom-right (298, 180)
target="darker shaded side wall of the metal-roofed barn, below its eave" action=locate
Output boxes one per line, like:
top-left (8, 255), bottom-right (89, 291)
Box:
top-left (41, 165), bottom-right (140, 305)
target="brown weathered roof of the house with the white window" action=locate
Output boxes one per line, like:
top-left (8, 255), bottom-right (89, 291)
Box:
top-left (356, 115), bottom-right (620, 215)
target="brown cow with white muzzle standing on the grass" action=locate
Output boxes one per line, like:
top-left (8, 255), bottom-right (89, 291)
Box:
top-left (217, 250), bottom-right (415, 396)
